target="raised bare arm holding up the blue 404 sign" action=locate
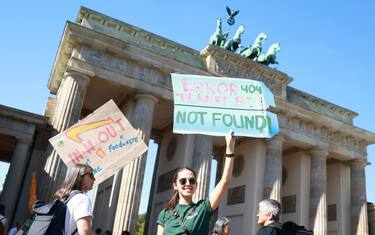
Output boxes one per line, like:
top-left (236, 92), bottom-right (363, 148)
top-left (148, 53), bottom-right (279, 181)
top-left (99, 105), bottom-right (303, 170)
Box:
top-left (209, 132), bottom-right (236, 210)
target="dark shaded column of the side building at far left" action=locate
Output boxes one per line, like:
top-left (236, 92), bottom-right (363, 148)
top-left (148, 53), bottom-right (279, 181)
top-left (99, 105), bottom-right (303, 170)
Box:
top-left (0, 139), bottom-right (32, 224)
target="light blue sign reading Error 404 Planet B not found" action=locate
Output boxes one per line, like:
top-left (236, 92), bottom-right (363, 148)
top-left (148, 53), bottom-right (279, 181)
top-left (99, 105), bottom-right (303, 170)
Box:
top-left (172, 74), bottom-right (279, 138)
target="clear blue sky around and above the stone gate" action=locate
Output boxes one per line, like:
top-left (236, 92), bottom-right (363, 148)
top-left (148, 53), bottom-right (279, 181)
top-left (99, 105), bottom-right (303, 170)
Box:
top-left (0, 0), bottom-right (375, 213)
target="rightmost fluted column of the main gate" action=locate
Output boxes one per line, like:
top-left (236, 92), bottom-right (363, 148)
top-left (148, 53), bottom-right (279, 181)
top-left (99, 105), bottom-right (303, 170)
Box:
top-left (350, 159), bottom-right (369, 235)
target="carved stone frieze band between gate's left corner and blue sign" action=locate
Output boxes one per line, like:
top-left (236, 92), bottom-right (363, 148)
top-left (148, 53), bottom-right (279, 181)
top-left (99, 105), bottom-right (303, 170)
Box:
top-left (79, 47), bottom-right (172, 89)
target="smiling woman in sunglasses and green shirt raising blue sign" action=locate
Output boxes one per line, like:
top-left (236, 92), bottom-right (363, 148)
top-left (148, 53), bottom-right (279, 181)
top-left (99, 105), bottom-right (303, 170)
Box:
top-left (157, 133), bottom-right (235, 235)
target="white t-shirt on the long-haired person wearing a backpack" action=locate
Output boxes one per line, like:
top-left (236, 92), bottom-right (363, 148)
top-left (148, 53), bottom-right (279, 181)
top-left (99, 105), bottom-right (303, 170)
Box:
top-left (65, 193), bottom-right (93, 235)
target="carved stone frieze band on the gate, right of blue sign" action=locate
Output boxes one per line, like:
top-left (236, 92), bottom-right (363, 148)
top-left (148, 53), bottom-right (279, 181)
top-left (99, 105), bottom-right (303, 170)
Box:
top-left (278, 113), bottom-right (367, 155)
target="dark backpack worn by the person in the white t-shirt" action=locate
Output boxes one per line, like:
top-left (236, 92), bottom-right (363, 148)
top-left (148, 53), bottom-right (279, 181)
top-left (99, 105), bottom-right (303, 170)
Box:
top-left (27, 191), bottom-right (80, 235)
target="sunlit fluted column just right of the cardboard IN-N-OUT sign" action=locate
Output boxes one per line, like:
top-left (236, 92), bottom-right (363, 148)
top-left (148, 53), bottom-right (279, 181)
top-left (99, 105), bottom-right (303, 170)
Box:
top-left (113, 94), bottom-right (157, 234)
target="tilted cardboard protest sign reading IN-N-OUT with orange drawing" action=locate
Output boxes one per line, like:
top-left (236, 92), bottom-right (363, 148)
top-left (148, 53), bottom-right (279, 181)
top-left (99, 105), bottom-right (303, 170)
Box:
top-left (49, 100), bottom-right (147, 185)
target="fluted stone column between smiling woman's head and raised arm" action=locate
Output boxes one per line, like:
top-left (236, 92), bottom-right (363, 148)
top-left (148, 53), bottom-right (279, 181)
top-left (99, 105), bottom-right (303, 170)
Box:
top-left (191, 135), bottom-right (212, 202)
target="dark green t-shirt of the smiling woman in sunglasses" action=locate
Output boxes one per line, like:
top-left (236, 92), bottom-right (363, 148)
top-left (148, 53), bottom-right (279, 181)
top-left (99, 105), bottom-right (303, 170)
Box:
top-left (157, 198), bottom-right (212, 235)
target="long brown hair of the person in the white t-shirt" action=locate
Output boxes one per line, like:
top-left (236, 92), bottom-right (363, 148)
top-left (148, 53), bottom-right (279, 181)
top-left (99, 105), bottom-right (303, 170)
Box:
top-left (53, 164), bottom-right (93, 200)
